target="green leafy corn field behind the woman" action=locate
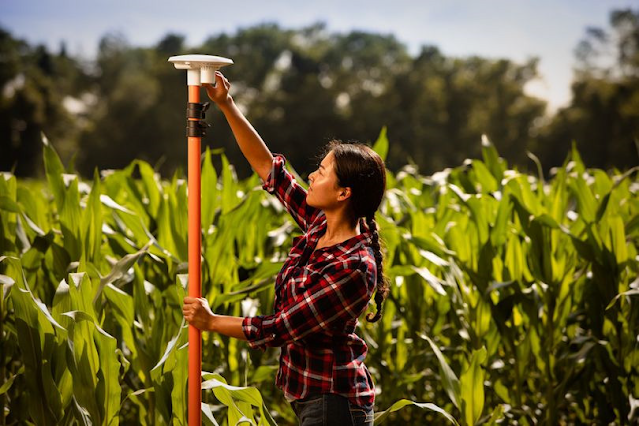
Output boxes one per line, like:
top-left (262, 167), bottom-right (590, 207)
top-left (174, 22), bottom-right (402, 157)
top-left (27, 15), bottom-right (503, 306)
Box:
top-left (0, 131), bottom-right (639, 425)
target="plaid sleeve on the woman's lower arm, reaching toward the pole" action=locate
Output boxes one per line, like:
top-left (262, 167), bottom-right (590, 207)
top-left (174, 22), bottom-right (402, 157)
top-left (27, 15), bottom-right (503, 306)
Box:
top-left (242, 261), bottom-right (375, 349)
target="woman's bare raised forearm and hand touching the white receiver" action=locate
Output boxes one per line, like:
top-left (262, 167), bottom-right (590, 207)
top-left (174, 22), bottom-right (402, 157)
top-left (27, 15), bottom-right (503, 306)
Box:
top-left (204, 71), bottom-right (273, 181)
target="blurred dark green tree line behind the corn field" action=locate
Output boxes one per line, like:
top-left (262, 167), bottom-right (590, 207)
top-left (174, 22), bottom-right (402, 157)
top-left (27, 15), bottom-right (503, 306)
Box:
top-left (0, 9), bottom-right (639, 176)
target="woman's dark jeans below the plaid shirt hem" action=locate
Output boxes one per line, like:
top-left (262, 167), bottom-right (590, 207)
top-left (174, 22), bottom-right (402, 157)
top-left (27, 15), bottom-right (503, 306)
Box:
top-left (291, 393), bottom-right (374, 426)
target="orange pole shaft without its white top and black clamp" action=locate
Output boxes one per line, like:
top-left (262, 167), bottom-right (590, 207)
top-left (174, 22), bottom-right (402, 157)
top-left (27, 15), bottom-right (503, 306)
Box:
top-left (187, 86), bottom-right (202, 426)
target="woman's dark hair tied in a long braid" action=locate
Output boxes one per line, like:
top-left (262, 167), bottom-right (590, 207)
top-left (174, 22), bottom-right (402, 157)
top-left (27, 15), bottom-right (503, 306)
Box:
top-left (326, 140), bottom-right (389, 322)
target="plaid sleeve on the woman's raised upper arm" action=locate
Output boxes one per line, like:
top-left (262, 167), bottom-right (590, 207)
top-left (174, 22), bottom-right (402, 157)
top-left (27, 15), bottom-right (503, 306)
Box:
top-left (262, 154), bottom-right (320, 232)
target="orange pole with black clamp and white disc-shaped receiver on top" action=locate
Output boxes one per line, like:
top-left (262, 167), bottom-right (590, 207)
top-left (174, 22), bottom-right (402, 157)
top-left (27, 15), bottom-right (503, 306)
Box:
top-left (169, 55), bottom-right (233, 426)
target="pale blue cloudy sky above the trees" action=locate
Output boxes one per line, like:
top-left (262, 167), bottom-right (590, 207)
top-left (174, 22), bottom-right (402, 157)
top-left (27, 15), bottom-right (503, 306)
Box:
top-left (0, 0), bottom-right (639, 111)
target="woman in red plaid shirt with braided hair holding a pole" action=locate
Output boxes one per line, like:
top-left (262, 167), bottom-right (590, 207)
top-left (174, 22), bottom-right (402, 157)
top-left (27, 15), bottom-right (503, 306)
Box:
top-left (183, 72), bottom-right (388, 426)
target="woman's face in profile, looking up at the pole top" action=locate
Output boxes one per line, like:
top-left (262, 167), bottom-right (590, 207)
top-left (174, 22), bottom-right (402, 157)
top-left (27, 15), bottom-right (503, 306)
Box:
top-left (306, 151), bottom-right (350, 210)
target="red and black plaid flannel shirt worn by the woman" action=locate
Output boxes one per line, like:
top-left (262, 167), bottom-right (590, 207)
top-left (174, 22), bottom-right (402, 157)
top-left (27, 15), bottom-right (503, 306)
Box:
top-left (242, 155), bottom-right (377, 408)
